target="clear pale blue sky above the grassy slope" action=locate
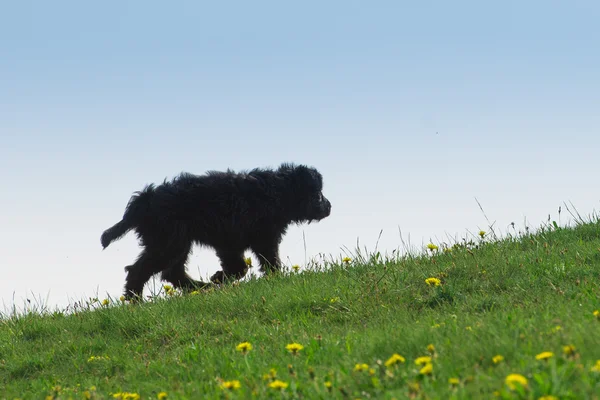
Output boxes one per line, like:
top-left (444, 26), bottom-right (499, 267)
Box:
top-left (0, 0), bottom-right (600, 312)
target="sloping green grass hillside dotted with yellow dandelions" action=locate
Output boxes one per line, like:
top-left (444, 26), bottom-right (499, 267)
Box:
top-left (0, 214), bottom-right (600, 399)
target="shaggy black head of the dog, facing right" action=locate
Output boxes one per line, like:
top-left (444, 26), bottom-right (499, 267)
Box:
top-left (278, 164), bottom-right (331, 223)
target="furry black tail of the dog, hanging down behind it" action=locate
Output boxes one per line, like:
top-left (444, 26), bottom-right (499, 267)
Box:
top-left (100, 184), bottom-right (154, 249)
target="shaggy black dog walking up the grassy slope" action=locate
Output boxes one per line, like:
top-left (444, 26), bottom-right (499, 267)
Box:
top-left (101, 164), bottom-right (331, 299)
